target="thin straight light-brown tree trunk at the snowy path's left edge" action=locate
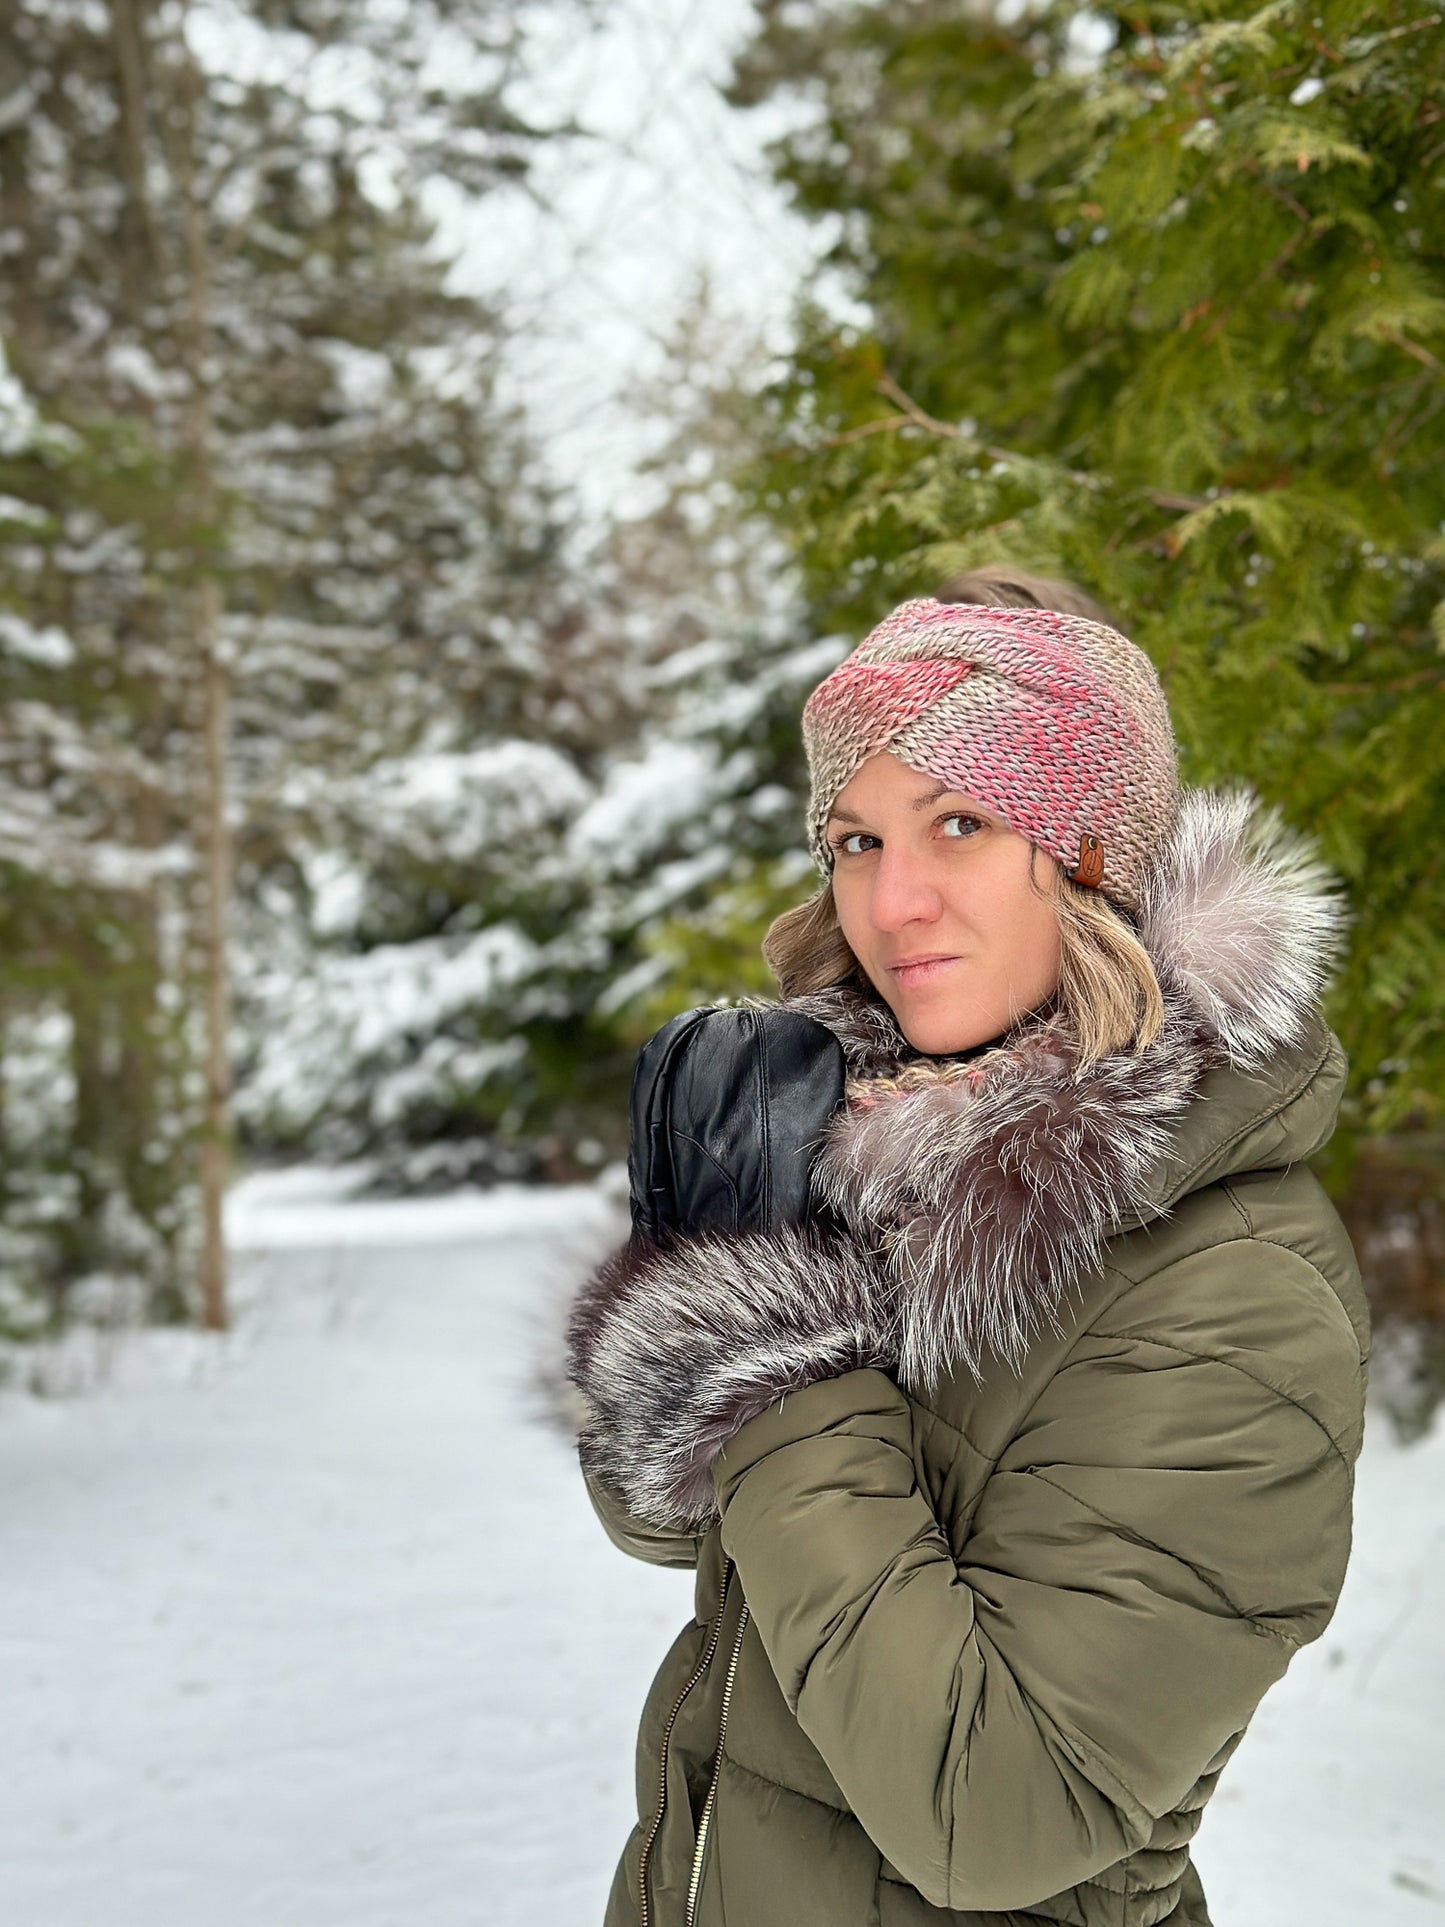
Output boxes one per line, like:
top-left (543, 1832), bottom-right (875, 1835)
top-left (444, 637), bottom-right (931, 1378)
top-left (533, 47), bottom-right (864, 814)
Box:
top-left (177, 13), bottom-right (231, 1332)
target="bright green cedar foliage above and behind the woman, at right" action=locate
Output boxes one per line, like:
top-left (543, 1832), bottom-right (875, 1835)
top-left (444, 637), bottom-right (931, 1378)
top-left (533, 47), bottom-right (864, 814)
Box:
top-left (734, 0), bottom-right (1445, 1143)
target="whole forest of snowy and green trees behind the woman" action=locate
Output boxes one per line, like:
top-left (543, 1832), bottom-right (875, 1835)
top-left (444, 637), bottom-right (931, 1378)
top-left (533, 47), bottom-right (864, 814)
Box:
top-left (0, 0), bottom-right (1445, 1428)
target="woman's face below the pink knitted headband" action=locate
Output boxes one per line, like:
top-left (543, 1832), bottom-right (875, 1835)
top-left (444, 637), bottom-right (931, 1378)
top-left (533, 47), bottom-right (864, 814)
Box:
top-left (827, 752), bottom-right (1060, 1056)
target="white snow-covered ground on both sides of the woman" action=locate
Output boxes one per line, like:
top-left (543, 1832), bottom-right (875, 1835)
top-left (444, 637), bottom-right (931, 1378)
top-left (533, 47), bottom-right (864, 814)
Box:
top-left (0, 1174), bottom-right (1445, 1927)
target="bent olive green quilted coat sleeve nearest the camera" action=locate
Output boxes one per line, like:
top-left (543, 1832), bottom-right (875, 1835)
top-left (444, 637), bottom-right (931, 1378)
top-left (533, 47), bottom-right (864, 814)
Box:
top-left (717, 1245), bottom-right (1358, 1910)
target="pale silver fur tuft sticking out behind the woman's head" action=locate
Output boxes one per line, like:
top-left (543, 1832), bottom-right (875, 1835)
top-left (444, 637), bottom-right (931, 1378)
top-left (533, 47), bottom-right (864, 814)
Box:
top-left (1139, 790), bottom-right (1345, 1066)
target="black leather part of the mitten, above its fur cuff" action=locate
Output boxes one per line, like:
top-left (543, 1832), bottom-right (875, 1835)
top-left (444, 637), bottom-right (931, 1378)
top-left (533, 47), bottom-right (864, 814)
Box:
top-left (628, 1008), bottom-right (846, 1243)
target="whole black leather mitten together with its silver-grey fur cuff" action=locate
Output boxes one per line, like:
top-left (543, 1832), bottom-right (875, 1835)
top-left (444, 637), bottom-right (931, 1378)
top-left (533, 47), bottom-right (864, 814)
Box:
top-left (568, 1008), bottom-right (878, 1532)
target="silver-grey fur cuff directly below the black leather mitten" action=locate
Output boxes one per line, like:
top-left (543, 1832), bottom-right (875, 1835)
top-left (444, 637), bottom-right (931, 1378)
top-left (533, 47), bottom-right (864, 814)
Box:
top-left (566, 1231), bottom-right (896, 1532)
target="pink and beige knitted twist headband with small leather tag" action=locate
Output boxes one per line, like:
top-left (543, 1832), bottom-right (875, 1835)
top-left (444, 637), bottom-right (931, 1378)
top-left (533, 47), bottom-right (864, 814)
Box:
top-left (803, 595), bottom-right (1179, 910)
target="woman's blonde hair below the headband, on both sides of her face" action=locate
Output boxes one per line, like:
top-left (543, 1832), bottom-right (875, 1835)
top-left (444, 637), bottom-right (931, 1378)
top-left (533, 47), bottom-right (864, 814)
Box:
top-left (763, 867), bottom-right (1164, 1069)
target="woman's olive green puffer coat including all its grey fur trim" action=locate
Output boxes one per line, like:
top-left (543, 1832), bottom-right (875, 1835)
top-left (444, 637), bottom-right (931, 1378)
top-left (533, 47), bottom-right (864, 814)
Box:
top-left (570, 796), bottom-right (1368, 1927)
